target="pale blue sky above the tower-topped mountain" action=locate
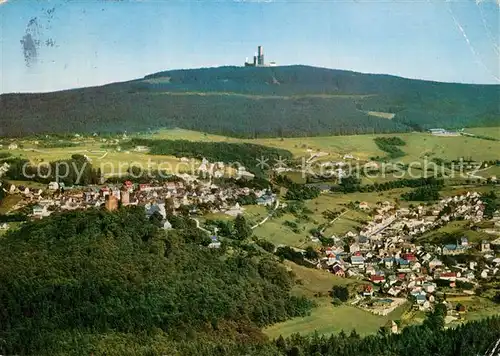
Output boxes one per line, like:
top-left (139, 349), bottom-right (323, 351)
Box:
top-left (0, 0), bottom-right (500, 93)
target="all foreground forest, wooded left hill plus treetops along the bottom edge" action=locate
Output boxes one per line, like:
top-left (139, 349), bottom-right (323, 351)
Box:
top-left (0, 207), bottom-right (500, 356)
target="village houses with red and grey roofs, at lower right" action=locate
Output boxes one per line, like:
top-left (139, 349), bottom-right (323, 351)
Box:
top-left (317, 193), bottom-right (500, 310)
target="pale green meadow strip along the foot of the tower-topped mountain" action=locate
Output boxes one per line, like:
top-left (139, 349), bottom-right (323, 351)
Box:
top-left (3, 128), bottom-right (500, 176)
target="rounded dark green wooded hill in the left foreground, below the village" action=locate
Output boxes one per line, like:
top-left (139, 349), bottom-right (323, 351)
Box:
top-left (0, 207), bottom-right (312, 355)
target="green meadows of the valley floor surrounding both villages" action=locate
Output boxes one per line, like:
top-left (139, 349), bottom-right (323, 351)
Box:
top-left (0, 128), bottom-right (500, 346)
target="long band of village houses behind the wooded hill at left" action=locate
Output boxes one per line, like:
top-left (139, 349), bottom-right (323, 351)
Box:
top-left (4, 174), bottom-right (276, 222)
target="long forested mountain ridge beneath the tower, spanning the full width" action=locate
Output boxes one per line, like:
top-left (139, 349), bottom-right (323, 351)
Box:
top-left (0, 66), bottom-right (500, 137)
